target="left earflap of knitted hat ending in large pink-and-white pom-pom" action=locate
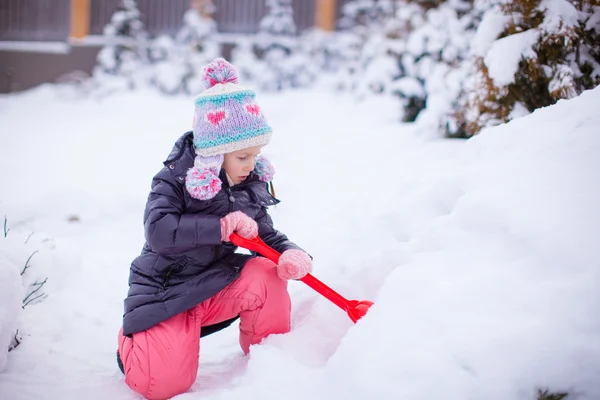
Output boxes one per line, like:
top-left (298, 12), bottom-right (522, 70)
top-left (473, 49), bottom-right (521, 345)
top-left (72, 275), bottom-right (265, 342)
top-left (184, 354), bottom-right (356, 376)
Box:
top-left (185, 154), bottom-right (224, 200)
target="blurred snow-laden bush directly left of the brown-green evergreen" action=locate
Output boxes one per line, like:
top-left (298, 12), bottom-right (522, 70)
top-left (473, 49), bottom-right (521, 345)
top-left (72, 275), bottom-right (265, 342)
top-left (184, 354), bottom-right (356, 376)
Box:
top-left (404, 0), bottom-right (489, 131)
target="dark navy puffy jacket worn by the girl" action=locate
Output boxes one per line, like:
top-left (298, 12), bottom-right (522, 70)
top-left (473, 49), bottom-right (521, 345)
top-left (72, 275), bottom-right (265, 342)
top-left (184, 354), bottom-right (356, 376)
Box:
top-left (123, 132), bottom-right (298, 335)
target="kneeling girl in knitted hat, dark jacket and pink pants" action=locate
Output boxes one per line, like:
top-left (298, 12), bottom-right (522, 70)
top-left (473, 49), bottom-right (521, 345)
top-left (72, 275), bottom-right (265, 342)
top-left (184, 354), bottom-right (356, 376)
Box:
top-left (117, 58), bottom-right (312, 399)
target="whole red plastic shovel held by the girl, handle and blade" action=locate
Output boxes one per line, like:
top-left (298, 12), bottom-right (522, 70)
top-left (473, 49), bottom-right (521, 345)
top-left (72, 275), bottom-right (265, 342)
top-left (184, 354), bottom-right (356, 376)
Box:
top-left (229, 233), bottom-right (373, 323)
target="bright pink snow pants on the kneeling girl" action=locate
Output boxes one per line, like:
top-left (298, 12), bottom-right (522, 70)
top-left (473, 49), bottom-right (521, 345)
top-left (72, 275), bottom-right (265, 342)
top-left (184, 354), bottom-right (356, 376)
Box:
top-left (119, 257), bottom-right (291, 400)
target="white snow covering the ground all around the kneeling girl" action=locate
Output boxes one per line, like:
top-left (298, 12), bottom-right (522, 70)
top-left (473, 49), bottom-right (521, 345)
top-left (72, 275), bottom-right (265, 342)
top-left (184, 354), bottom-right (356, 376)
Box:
top-left (0, 86), bottom-right (600, 400)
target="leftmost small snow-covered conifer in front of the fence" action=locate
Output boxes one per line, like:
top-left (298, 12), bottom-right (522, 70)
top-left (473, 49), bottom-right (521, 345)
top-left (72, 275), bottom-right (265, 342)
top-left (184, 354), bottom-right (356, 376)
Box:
top-left (93, 0), bottom-right (149, 93)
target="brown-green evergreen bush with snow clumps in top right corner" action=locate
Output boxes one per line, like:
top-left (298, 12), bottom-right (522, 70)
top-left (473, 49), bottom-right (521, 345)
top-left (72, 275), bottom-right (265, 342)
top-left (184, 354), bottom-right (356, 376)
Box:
top-left (463, 0), bottom-right (600, 136)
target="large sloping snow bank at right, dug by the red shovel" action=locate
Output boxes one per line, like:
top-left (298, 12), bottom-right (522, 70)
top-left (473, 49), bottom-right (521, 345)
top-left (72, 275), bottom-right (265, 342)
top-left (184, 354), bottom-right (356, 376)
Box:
top-left (322, 89), bottom-right (600, 400)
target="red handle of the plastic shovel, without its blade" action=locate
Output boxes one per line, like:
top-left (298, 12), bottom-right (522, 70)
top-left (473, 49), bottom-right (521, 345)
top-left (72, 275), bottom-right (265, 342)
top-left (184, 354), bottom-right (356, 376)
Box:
top-left (229, 232), bottom-right (351, 312)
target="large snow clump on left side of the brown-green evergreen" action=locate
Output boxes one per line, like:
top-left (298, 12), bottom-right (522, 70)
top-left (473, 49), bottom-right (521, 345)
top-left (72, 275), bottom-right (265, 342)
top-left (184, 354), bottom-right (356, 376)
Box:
top-left (484, 29), bottom-right (539, 86)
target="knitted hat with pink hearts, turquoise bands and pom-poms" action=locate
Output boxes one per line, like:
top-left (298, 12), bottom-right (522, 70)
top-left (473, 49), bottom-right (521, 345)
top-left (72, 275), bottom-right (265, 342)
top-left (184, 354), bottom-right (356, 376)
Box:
top-left (186, 58), bottom-right (274, 200)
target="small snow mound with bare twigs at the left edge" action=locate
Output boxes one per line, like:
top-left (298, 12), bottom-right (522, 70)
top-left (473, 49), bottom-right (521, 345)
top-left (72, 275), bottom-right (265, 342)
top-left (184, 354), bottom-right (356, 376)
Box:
top-left (0, 217), bottom-right (54, 371)
